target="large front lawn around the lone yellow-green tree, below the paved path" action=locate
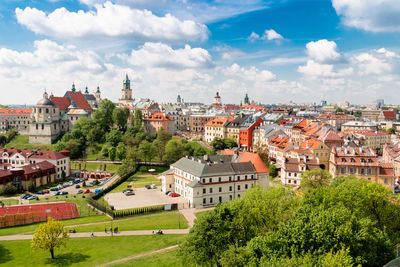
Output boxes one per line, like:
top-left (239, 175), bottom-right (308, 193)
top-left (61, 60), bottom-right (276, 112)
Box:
top-left (0, 235), bottom-right (185, 266)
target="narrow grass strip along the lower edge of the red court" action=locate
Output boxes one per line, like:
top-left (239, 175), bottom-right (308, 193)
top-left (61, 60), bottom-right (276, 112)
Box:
top-left (0, 215), bottom-right (110, 236)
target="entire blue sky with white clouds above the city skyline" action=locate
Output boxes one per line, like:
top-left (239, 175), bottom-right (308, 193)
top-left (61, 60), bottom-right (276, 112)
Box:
top-left (0, 0), bottom-right (400, 105)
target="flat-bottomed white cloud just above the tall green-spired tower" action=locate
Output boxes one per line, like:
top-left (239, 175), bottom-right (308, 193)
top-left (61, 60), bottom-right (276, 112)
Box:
top-left (120, 43), bottom-right (214, 69)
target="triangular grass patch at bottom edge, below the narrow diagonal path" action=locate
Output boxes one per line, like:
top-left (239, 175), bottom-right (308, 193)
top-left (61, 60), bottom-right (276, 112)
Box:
top-left (110, 249), bottom-right (179, 267)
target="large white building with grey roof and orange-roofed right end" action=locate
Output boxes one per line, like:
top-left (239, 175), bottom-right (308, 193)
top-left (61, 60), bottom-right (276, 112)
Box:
top-left (161, 152), bottom-right (269, 207)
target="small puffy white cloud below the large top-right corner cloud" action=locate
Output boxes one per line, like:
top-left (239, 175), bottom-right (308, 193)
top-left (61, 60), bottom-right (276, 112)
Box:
top-left (306, 39), bottom-right (342, 63)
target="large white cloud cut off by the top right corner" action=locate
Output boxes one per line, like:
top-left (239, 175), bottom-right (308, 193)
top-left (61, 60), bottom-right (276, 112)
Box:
top-left (332, 0), bottom-right (400, 32)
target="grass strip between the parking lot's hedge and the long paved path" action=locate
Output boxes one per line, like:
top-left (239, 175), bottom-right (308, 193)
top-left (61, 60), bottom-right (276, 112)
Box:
top-left (74, 212), bottom-right (188, 232)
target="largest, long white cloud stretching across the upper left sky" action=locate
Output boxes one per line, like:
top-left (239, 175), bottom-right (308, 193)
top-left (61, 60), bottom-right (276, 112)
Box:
top-left (15, 1), bottom-right (208, 42)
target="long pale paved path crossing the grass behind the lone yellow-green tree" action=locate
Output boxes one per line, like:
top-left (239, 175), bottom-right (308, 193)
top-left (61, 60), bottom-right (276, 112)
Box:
top-left (0, 229), bottom-right (189, 241)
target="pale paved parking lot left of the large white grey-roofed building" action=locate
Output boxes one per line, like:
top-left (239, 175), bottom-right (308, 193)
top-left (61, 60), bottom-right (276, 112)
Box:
top-left (104, 188), bottom-right (187, 210)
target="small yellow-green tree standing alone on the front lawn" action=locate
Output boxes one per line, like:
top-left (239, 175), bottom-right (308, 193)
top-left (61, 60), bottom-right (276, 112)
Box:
top-left (31, 217), bottom-right (68, 259)
